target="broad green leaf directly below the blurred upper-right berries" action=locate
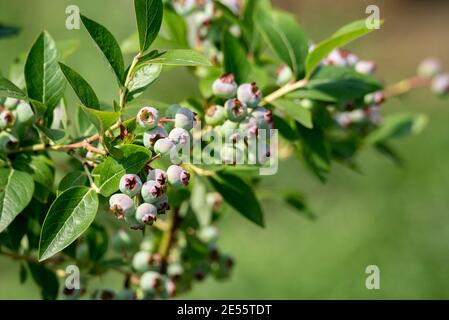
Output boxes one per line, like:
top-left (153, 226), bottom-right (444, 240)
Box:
top-left (306, 66), bottom-right (382, 105)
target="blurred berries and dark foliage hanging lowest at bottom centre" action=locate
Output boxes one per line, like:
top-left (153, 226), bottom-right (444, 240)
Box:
top-left (122, 226), bottom-right (234, 299)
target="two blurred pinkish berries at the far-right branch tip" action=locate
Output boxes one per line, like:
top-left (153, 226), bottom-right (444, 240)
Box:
top-left (418, 58), bottom-right (449, 96)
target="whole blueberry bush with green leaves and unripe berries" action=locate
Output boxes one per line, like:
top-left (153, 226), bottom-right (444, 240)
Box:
top-left (0, 0), bottom-right (449, 299)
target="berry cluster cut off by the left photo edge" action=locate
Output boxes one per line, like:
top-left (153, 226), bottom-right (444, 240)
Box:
top-left (0, 98), bottom-right (34, 152)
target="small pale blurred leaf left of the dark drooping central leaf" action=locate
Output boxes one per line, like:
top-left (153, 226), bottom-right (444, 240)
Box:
top-left (190, 176), bottom-right (212, 226)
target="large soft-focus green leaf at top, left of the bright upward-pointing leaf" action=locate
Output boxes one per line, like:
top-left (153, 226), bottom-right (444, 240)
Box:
top-left (256, 10), bottom-right (309, 78)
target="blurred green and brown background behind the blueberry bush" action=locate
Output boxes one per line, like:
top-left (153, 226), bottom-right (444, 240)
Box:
top-left (0, 0), bottom-right (449, 299)
